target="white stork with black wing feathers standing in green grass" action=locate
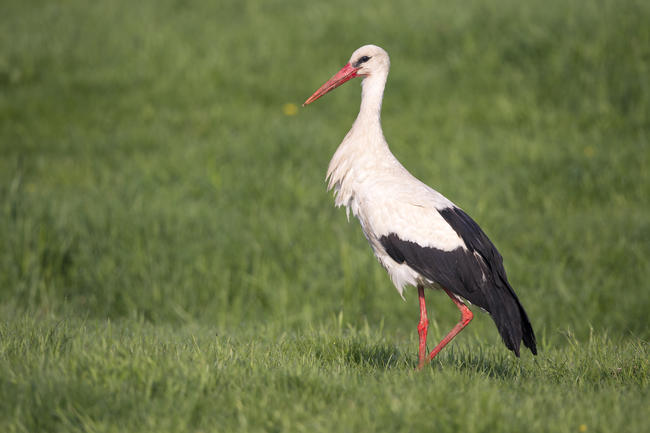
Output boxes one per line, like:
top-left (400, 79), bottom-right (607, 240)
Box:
top-left (303, 45), bottom-right (537, 369)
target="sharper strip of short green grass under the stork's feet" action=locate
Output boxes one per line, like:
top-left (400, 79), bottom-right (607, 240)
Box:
top-left (0, 318), bottom-right (649, 432)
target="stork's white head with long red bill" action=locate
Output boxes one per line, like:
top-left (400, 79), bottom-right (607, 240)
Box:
top-left (302, 45), bottom-right (390, 107)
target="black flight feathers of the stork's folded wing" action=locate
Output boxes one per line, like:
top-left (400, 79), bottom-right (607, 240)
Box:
top-left (380, 207), bottom-right (537, 356)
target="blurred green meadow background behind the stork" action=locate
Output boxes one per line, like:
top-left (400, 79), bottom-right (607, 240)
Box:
top-left (0, 0), bottom-right (650, 430)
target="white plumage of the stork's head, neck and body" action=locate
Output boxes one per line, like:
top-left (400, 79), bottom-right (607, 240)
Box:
top-left (327, 45), bottom-right (464, 295)
